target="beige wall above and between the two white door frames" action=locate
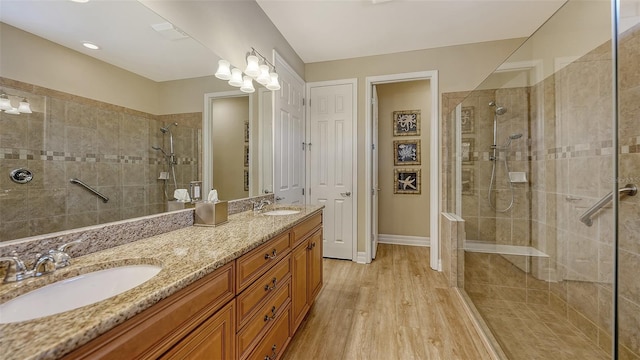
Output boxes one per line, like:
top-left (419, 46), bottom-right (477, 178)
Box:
top-left (305, 39), bottom-right (524, 252)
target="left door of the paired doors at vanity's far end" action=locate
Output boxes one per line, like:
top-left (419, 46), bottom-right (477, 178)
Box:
top-left (291, 241), bottom-right (309, 336)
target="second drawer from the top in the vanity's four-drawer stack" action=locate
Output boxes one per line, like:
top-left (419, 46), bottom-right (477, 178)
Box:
top-left (237, 256), bottom-right (291, 329)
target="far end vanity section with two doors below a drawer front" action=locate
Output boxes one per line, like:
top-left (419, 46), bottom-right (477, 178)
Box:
top-left (290, 215), bottom-right (322, 336)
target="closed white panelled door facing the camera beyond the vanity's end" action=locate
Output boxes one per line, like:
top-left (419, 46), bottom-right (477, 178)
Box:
top-left (309, 84), bottom-right (356, 260)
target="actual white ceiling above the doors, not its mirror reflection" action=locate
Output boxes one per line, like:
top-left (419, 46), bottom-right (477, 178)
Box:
top-left (257, 0), bottom-right (565, 63)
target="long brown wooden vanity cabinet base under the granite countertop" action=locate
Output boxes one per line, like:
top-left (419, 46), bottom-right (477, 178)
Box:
top-left (64, 213), bottom-right (322, 360)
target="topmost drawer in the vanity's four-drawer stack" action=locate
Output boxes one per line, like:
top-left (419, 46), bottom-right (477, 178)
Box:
top-left (236, 232), bottom-right (291, 294)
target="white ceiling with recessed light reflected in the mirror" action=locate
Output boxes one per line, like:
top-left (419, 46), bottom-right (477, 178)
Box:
top-left (0, 0), bottom-right (218, 82)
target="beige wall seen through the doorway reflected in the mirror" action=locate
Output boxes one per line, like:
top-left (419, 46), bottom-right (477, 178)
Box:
top-left (211, 96), bottom-right (249, 200)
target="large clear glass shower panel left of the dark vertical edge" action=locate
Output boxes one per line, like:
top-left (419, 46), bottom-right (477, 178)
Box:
top-left (452, 0), bottom-right (616, 359)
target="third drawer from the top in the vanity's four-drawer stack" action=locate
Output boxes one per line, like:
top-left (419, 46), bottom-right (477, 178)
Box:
top-left (238, 280), bottom-right (291, 359)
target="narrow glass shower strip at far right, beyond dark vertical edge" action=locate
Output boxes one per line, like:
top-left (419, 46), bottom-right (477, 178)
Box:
top-left (615, 0), bottom-right (640, 359)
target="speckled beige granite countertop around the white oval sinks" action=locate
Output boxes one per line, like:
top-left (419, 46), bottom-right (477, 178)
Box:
top-left (0, 205), bottom-right (322, 360)
